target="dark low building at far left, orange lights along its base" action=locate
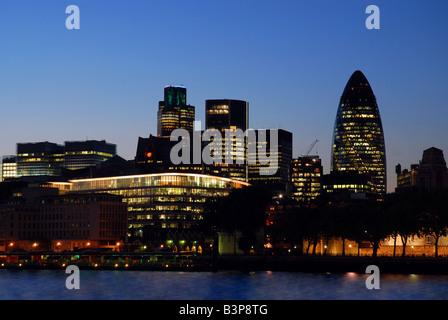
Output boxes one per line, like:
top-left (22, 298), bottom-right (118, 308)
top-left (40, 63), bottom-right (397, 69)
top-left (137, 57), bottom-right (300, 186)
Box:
top-left (0, 187), bottom-right (128, 251)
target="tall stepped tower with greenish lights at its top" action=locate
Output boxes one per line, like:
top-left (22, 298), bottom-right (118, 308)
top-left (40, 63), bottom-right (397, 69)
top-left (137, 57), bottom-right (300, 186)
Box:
top-left (157, 86), bottom-right (195, 137)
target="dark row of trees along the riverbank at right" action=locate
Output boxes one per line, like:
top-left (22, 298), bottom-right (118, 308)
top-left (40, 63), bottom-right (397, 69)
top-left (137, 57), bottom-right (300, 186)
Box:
top-left (203, 187), bottom-right (448, 257)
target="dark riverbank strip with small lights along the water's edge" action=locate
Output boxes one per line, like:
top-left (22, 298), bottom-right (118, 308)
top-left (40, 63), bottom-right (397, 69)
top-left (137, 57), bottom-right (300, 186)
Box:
top-left (0, 252), bottom-right (448, 275)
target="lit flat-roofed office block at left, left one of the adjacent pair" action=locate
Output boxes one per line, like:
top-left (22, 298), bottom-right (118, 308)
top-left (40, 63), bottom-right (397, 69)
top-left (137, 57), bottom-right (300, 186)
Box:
top-left (17, 141), bottom-right (64, 177)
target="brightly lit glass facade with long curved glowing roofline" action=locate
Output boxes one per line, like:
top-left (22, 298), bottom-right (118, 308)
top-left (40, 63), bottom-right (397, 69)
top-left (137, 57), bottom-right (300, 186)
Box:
top-left (52, 173), bottom-right (249, 232)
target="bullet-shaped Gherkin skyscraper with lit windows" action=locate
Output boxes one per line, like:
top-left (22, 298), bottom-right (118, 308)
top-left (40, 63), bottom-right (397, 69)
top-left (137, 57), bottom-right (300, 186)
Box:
top-left (331, 70), bottom-right (387, 196)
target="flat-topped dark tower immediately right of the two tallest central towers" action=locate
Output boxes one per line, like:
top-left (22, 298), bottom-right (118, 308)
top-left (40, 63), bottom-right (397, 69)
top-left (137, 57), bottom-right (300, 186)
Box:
top-left (247, 129), bottom-right (292, 194)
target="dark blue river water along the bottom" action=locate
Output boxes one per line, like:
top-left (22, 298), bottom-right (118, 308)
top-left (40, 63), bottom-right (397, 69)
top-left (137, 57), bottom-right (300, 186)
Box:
top-left (0, 269), bottom-right (448, 300)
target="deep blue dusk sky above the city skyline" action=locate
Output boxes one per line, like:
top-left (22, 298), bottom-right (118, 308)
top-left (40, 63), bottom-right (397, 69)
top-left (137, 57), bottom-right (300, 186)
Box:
top-left (0, 0), bottom-right (448, 191)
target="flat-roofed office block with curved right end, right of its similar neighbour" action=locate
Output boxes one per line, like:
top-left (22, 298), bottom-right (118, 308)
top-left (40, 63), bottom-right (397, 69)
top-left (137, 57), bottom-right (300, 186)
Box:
top-left (64, 140), bottom-right (117, 170)
